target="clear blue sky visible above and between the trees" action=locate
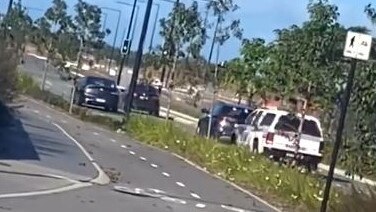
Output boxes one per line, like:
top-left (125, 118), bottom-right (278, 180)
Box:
top-left (0, 0), bottom-right (376, 61)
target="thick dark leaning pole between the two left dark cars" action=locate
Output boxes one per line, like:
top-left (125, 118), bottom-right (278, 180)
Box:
top-left (124, 0), bottom-right (153, 117)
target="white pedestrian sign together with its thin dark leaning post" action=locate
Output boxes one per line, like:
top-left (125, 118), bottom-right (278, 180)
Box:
top-left (320, 31), bottom-right (372, 212)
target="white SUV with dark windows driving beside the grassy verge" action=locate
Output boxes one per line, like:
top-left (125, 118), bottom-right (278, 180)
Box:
top-left (237, 109), bottom-right (324, 170)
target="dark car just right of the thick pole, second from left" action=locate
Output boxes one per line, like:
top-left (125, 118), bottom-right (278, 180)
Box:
top-left (125, 83), bottom-right (159, 116)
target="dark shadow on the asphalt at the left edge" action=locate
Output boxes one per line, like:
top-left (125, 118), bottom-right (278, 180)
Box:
top-left (0, 103), bottom-right (39, 160)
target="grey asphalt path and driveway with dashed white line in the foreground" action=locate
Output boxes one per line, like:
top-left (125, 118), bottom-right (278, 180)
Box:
top-left (0, 96), bottom-right (275, 212)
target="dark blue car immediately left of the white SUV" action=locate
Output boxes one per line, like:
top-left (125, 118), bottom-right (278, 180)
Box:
top-left (196, 101), bottom-right (254, 143)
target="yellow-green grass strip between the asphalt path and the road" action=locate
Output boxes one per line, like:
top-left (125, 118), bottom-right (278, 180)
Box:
top-left (15, 72), bottom-right (376, 211)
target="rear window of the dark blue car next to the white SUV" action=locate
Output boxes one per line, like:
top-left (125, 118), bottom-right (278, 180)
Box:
top-left (213, 104), bottom-right (252, 124)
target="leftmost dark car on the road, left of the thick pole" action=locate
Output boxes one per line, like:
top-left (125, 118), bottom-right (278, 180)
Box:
top-left (74, 76), bottom-right (119, 112)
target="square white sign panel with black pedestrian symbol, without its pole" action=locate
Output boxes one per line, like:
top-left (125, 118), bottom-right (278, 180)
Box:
top-left (343, 31), bottom-right (372, 60)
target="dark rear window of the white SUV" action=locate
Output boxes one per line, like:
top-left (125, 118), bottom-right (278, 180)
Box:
top-left (275, 116), bottom-right (321, 137)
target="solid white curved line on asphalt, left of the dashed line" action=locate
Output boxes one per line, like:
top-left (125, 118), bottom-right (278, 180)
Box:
top-left (53, 123), bottom-right (110, 185)
